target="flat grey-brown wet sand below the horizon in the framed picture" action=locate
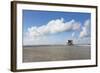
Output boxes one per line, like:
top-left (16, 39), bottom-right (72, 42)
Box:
top-left (23, 45), bottom-right (91, 62)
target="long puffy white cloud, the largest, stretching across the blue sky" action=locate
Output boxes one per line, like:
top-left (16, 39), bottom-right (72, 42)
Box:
top-left (26, 18), bottom-right (81, 37)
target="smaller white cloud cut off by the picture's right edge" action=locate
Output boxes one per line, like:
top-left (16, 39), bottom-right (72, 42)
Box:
top-left (79, 20), bottom-right (90, 38)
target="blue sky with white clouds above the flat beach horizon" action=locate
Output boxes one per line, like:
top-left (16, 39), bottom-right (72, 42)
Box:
top-left (22, 10), bottom-right (91, 45)
